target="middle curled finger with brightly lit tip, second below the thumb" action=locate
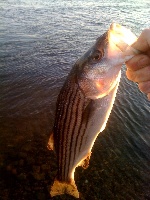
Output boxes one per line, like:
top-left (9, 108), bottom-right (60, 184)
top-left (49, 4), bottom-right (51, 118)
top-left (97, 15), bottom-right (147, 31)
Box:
top-left (126, 66), bottom-right (150, 83)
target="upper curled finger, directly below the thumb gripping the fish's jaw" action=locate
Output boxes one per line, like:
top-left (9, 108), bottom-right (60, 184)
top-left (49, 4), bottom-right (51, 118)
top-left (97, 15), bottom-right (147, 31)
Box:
top-left (126, 54), bottom-right (150, 71)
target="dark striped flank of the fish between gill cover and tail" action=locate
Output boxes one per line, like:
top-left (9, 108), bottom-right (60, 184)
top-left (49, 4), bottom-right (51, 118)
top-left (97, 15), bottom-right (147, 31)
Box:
top-left (54, 79), bottom-right (89, 181)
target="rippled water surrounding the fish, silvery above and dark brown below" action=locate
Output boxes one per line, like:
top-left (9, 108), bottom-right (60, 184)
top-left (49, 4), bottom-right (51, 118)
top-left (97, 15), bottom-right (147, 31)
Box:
top-left (0, 0), bottom-right (150, 200)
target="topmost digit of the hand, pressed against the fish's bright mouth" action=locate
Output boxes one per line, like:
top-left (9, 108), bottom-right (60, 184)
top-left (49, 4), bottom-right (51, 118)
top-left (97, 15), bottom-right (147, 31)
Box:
top-left (132, 29), bottom-right (150, 52)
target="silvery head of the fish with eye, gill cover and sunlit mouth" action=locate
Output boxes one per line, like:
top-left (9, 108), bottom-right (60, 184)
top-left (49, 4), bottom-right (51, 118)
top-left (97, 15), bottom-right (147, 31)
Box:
top-left (76, 24), bottom-right (137, 99)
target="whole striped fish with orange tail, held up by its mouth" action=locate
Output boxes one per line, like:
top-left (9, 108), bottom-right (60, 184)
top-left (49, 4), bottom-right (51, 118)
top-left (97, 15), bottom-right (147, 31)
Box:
top-left (48, 23), bottom-right (137, 198)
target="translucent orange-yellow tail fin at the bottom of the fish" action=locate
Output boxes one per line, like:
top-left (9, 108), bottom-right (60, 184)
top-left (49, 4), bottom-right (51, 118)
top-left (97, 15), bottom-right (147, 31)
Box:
top-left (50, 180), bottom-right (79, 198)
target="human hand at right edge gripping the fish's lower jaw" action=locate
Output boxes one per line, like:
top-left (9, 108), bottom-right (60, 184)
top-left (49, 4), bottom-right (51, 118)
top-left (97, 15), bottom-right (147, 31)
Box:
top-left (126, 29), bottom-right (150, 100)
